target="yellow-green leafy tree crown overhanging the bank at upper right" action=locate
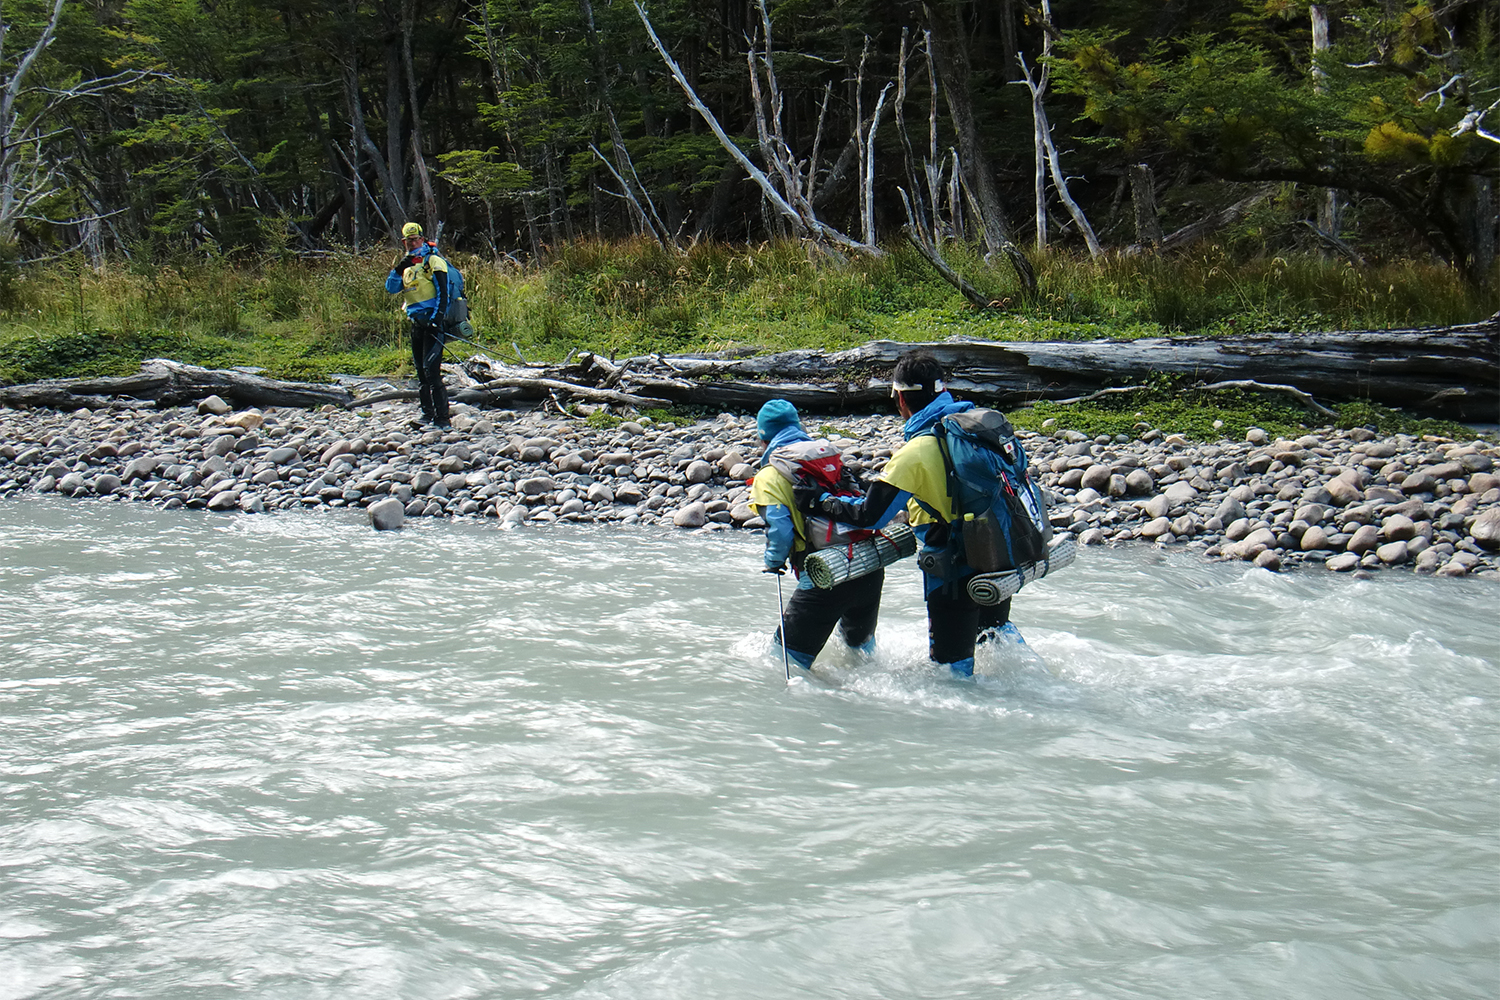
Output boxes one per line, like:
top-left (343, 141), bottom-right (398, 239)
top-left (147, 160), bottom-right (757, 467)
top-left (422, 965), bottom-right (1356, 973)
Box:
top-left (1056, 0), bottom-right (1500, 279)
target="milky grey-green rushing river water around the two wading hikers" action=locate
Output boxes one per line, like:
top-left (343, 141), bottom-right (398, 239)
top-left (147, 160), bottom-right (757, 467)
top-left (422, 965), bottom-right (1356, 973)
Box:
top-left (0, 501), bottom-right (1500, 1000)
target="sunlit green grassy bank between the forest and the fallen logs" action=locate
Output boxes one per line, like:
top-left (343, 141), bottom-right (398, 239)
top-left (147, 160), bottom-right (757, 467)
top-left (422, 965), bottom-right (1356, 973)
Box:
top-left (0, 241), bottom-right (1500, 440)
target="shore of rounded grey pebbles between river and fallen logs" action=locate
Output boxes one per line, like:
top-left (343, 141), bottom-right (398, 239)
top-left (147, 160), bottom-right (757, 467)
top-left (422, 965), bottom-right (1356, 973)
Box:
top-left (0, 397), bottom-right (1500, 579)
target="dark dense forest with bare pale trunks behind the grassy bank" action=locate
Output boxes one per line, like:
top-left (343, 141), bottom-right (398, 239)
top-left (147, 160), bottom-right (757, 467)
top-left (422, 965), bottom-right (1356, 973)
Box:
top-left (0, 0), bottom-right (1500, 288)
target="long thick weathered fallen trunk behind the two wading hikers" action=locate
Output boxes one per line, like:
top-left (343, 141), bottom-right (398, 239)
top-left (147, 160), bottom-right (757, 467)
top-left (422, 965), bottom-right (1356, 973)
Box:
top-left (560, 316), bottom-right (1500, 423)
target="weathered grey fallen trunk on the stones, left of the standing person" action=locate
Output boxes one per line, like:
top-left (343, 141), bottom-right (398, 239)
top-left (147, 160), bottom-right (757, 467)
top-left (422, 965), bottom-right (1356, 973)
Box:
top-left (0, 358), bottom-right (351, 409)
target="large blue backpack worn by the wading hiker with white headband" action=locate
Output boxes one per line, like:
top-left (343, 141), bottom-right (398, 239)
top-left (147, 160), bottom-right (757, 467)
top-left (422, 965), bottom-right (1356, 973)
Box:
top-left (918, 408), bottom-right (1052, 580)
